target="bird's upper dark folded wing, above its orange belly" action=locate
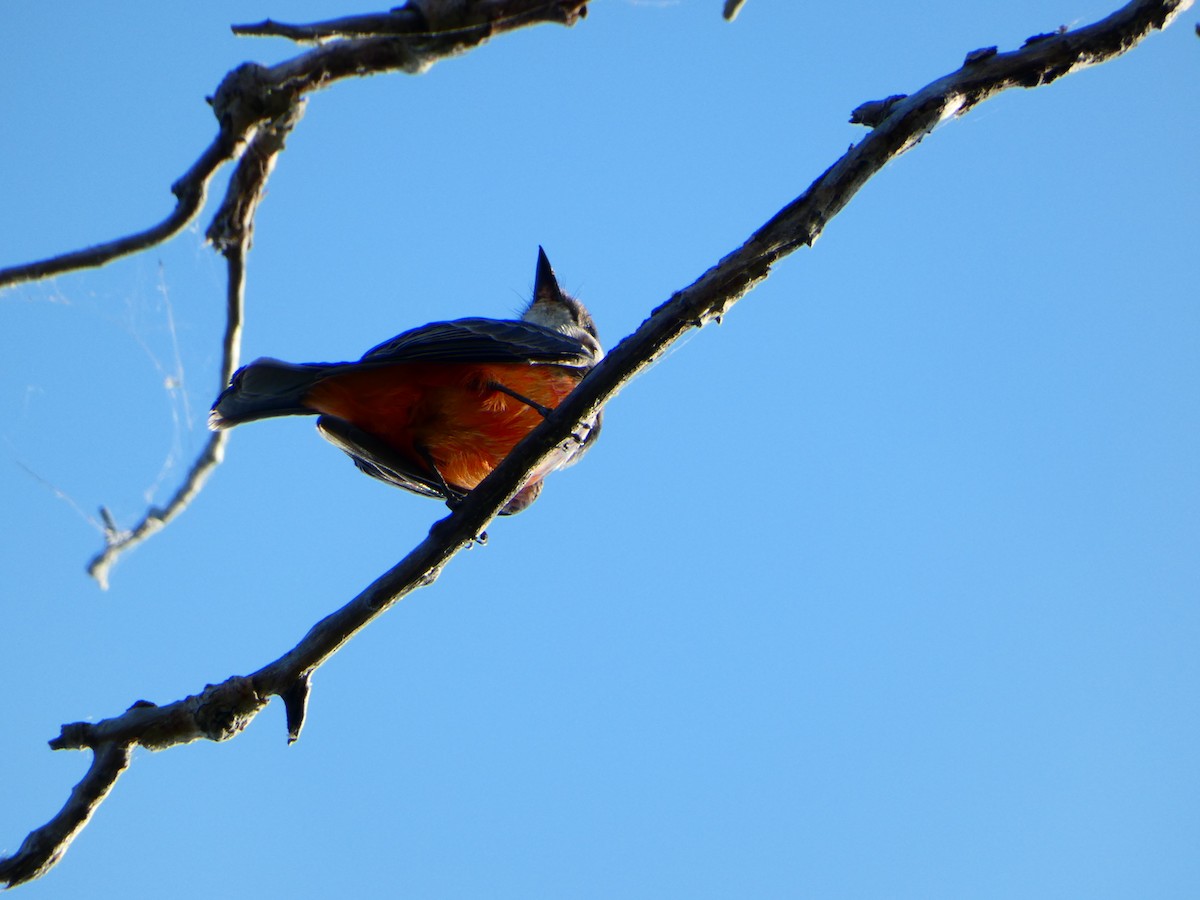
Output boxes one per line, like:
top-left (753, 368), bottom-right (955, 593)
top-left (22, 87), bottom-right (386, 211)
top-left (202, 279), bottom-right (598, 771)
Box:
top-left (361, 319), bottom-right (595, 368)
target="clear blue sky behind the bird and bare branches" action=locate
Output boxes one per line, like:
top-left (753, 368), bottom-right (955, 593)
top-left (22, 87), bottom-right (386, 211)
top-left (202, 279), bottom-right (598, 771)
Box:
top-left (0, 0), bottom-right (1200, 899)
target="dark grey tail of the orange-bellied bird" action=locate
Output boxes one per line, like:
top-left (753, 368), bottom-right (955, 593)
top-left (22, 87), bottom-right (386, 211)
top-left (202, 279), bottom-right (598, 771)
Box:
top-left (209, 358), bottom-right (336, 431)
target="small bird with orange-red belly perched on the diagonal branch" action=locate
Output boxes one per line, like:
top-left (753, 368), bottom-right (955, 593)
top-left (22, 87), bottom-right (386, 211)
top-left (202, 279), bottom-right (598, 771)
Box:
top-left (209, 247), bottom-right (604, 515)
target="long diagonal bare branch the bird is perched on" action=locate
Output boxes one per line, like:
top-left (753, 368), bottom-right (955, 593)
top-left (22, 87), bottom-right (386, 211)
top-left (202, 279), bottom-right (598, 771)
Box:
top-left (0, 0), bottom-right (1192, 884)
